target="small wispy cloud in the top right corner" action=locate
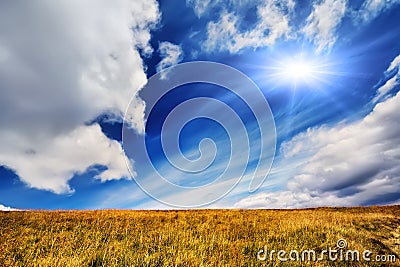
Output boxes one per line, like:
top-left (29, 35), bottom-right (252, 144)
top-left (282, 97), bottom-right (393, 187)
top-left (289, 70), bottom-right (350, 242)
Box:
top-left (356, 0), bottom-right (400, 22)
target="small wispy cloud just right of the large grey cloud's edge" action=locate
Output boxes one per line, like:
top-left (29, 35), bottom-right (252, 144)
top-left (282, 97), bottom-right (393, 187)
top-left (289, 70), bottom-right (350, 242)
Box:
top-left (157, 42), bottom-right (183, 76)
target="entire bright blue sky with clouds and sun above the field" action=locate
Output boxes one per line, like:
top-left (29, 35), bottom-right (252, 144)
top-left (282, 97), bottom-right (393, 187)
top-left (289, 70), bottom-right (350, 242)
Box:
top-left (0, 0), bottom-right (400, 210)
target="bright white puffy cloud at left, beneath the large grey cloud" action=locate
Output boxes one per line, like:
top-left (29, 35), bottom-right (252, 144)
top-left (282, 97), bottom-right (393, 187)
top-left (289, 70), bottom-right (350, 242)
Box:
top-left (0, 124), bottom-right (130, 193)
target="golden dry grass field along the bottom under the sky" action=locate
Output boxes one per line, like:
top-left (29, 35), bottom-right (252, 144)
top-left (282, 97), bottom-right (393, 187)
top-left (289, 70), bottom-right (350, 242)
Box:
top-left (0, 206), bottom-right (400, 266)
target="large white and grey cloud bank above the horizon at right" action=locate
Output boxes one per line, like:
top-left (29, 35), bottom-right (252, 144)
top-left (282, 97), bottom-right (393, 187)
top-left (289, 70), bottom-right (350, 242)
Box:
top-left (237, 57), bottom-right (400, 208)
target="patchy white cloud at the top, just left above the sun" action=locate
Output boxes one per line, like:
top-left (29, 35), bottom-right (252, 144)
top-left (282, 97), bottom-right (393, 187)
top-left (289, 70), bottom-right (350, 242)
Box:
top-left (203, 0), bottom-right (294, 53)
